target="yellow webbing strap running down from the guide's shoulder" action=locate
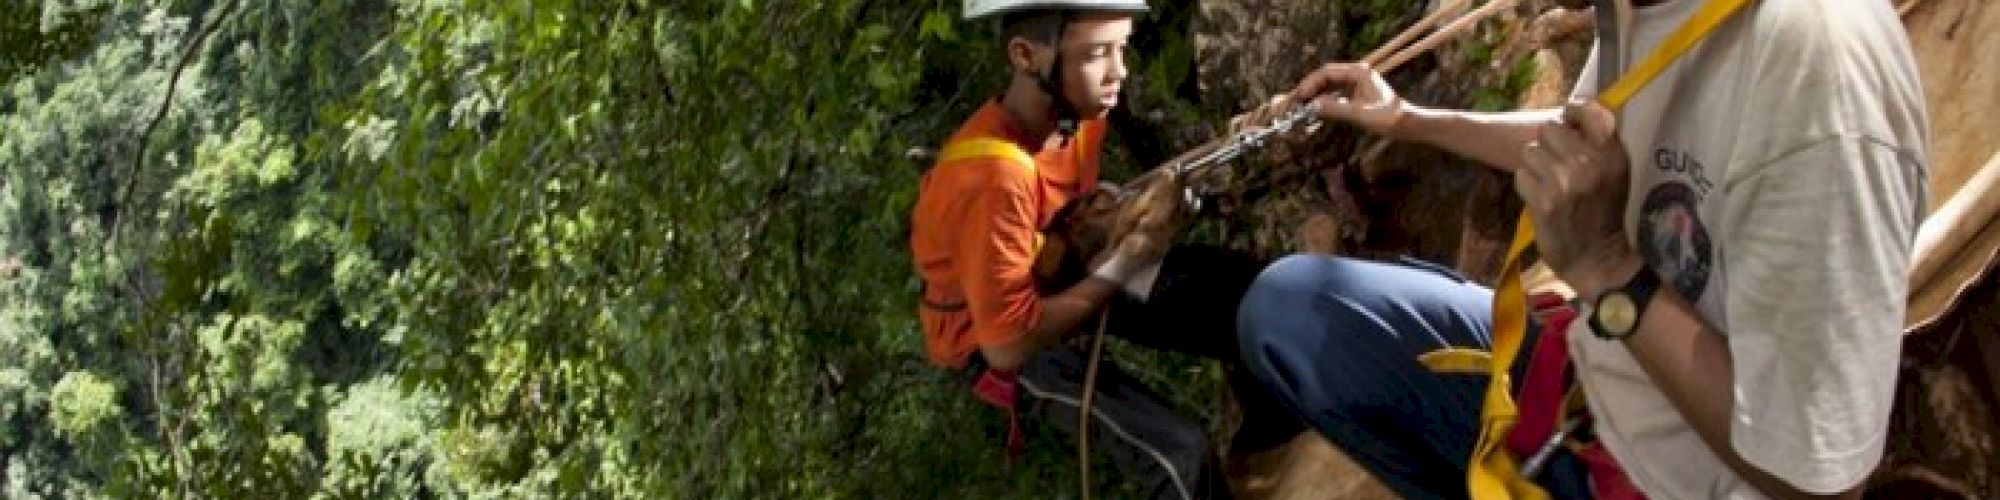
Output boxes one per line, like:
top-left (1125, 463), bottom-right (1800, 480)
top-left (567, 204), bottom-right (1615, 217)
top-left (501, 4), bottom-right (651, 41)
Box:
top-left (1466, 0), bottom-right (1750, 500)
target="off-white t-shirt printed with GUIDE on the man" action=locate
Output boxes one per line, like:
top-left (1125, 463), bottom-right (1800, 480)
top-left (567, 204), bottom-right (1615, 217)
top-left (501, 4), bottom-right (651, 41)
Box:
top-left (1568, 0), bottom-right (1928, 498)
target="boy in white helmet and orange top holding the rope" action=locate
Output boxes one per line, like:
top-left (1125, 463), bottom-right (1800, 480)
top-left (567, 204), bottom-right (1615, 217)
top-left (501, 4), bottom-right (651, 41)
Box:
top-left (910, 0), bottom-right (1302, 498)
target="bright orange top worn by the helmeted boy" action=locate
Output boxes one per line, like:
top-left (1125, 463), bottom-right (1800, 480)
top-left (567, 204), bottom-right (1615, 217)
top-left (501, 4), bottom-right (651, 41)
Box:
top-left (910, 100), bottom-right (1104, 368)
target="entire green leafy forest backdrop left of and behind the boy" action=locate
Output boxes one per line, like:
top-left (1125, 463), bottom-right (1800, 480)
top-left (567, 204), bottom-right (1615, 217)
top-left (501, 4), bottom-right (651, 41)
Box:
top-left (0, 0), bottom-right (1248, 498)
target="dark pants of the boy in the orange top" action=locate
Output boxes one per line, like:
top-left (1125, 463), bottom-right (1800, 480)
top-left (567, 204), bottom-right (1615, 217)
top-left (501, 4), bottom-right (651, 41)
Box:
top-left (968, 246), bottom-right (1304, 498)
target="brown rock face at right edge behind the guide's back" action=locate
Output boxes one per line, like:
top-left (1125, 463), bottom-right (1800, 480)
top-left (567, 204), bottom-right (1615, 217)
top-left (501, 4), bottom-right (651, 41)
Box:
top-left (1870, 0), bottom-right (2000, 498)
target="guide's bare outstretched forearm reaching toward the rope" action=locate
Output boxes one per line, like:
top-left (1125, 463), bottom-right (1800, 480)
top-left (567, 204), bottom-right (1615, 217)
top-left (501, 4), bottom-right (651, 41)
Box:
top-left (1390, 104), bottom-right (1560, 172)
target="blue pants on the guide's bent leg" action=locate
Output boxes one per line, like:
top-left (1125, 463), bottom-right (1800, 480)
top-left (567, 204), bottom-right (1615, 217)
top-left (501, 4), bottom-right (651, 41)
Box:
top-left (1236, 254), bottom-right (1590, 498)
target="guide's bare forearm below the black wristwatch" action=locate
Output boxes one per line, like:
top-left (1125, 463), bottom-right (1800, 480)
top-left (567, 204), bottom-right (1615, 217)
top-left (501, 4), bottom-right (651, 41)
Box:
top-left (1624, 286), bottom-right (1858, 498)
